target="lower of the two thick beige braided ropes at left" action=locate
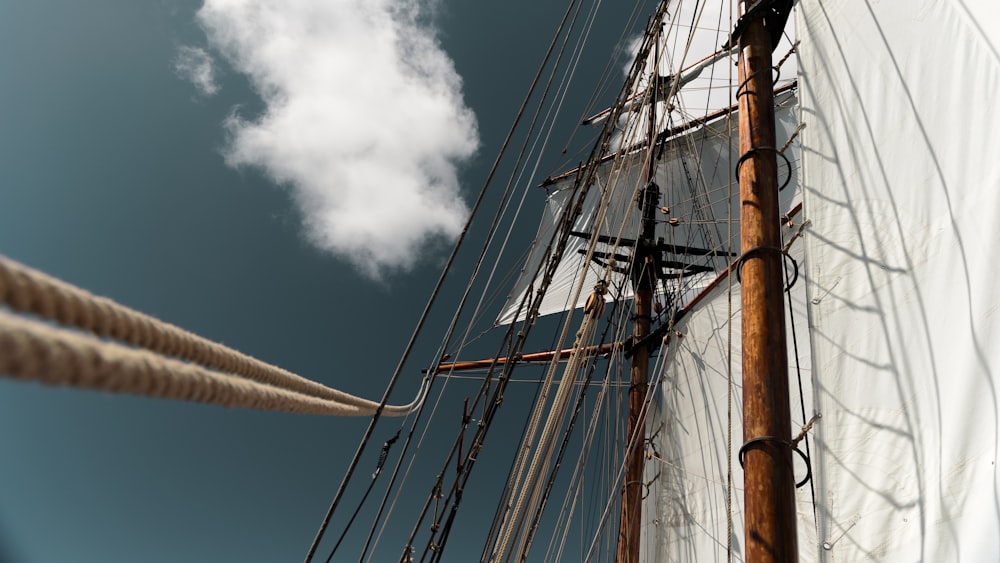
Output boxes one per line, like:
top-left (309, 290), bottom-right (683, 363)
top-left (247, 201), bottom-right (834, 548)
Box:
top-left (0, 312), bottom-right (405, 416)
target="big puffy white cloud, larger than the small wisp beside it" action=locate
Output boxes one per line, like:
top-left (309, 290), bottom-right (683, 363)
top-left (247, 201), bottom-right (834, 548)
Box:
top-left (198, 0), bottom-right (478, 278)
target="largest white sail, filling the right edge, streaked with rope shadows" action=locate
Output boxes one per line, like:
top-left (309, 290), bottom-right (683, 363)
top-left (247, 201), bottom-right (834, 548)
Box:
top-left (799, 0), bottom-right (1000, 561)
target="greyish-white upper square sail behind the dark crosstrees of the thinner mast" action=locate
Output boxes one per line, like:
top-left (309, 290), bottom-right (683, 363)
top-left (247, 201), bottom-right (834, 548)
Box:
top-left (497, 91), bottom-right (798, 324)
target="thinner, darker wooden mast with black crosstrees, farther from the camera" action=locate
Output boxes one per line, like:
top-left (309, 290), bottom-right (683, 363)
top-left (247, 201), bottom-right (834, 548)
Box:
top-left (617, 20), bottom-right (661, 563)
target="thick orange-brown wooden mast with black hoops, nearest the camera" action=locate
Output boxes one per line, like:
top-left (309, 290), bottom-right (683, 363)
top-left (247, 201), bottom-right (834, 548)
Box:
top-left (736, 5), bottom-right (798, 563)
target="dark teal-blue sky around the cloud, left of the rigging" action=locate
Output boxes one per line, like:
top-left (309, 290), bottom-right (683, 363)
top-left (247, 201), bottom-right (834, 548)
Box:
top-left (0, 0), bottom-right (648, 562)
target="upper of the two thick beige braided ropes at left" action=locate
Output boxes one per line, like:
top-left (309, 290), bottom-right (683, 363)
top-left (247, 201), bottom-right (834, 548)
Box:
top-left (0, 256), bottom-right (406, 414)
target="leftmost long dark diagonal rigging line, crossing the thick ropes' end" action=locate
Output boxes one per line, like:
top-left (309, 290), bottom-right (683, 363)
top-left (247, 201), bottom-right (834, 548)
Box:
top-left (296, 0), bottom-right (592, 563)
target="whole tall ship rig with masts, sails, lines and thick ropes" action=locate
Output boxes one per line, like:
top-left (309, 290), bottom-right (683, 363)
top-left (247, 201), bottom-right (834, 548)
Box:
top-left (0, 0), bottom-right (1000, 563)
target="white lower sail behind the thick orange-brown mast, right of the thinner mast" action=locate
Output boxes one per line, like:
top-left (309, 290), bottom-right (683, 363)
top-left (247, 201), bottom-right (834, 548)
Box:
top-left (643, 214), bottom-right (815, 562)
